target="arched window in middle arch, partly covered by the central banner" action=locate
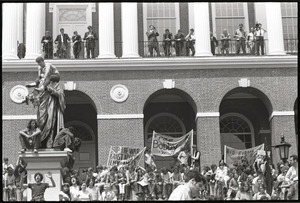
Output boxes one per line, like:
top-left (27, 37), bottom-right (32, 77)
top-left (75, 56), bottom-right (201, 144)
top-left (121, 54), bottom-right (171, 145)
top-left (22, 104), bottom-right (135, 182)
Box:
top-left (145, 113), bottom-right (186, 148)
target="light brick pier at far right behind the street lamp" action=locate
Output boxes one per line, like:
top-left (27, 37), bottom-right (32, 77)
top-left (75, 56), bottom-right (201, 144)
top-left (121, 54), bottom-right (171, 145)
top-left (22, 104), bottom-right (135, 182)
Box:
top-left (270, 115), bottom-right (298, 163)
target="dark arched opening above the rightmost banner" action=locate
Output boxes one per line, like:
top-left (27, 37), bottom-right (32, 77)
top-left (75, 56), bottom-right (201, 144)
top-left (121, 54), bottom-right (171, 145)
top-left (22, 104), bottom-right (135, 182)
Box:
top-left (220, 87), bottom-right (273, 155)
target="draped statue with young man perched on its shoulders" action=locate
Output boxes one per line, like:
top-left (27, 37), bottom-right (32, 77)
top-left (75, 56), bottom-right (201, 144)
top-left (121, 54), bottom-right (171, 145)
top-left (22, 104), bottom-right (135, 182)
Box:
top-left (23, 57), bottom-right (66, 148)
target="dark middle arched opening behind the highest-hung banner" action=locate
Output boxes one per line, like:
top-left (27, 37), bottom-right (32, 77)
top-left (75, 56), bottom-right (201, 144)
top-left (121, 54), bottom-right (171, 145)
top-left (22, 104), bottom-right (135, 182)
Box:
top-left (144, 89), bottom-right (197, 168)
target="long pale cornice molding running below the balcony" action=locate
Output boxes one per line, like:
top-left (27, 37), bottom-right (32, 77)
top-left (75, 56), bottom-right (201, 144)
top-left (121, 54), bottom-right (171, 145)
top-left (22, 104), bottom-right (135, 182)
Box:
top-left (2, 56), bottom-right (298, 72)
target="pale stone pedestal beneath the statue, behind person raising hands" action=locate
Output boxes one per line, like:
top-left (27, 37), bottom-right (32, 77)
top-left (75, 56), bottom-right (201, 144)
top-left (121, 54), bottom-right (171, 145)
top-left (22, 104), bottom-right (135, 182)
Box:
top-left (19, 149), bottom-right (68, 201)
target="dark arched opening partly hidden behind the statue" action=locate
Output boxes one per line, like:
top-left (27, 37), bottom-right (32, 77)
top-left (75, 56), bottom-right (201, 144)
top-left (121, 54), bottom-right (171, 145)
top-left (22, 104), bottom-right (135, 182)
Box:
top-left (64, 90), bottom-right (98, 172)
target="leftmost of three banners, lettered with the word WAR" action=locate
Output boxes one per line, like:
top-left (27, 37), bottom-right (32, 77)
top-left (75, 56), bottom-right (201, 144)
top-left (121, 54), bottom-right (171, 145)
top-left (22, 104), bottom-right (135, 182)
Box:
top-left (106, 146), bottom-right (146, 167)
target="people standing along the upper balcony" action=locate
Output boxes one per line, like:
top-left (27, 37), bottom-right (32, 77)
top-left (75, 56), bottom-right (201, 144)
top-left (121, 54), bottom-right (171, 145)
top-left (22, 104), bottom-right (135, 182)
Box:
top-left (18, 23), bottom-right (266, 59)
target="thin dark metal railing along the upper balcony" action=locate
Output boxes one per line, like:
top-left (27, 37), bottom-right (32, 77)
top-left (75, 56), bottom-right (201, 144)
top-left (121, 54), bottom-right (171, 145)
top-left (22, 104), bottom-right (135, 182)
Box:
top-left (18, 39), bottom-right (298, 59)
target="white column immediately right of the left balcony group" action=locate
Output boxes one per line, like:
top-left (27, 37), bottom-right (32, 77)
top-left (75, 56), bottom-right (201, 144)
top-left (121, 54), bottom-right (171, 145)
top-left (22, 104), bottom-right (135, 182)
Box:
top-left (98, 3), bottom-right (116, 58)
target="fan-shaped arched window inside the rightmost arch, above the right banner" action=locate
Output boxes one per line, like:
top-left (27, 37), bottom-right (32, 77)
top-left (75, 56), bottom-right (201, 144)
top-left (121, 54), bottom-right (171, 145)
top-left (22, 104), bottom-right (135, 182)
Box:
top-left (220, 113), bottom-right (254, 152)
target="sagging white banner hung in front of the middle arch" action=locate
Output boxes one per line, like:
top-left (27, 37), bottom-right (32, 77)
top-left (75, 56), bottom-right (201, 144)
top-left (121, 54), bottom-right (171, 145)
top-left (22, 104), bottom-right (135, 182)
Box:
top-left (151, 130), bottom-right (193, 156)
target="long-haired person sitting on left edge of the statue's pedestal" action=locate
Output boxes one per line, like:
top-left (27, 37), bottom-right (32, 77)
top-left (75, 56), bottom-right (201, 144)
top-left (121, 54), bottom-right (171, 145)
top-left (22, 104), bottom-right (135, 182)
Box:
top-left (19, 119), bottom-right (41, 153)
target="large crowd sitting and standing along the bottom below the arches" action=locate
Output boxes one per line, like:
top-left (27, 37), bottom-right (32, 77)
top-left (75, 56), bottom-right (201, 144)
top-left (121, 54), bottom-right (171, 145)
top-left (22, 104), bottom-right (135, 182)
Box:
top-left (2, 147), bottom-right (298, 201)
